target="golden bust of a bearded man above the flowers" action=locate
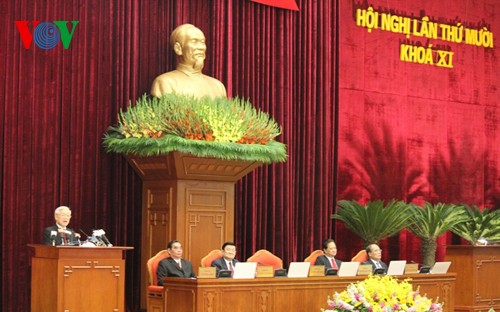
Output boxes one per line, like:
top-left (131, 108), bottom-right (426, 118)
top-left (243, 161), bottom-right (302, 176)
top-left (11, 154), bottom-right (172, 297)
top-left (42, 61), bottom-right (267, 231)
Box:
top-left (151, 24), bottom-right (227, 98)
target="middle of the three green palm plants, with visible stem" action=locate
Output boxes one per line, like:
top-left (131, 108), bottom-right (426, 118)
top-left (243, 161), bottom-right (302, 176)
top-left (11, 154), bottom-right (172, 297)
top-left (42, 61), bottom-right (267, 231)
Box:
top-left (409, 202), bottom-right (467, 266)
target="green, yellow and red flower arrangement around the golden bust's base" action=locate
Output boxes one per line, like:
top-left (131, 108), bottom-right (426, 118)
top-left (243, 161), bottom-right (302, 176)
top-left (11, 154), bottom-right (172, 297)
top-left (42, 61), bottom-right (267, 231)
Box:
top-left (104, 94), bottom-right (287, 163)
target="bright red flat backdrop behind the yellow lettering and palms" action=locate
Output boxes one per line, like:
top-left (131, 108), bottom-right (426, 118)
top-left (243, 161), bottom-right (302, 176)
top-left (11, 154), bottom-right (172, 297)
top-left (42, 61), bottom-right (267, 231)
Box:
top-left (337, 0), bottom-right (500, 262)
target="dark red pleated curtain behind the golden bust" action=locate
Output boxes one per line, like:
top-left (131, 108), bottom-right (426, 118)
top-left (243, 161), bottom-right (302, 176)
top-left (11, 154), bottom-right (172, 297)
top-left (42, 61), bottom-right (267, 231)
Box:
top-left (0, 0), bottom-right (336, 311)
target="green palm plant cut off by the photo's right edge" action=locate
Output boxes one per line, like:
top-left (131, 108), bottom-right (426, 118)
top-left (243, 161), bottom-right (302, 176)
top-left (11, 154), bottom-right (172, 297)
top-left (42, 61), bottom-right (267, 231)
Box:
top-left (451, 205), bottom-right (500, 245)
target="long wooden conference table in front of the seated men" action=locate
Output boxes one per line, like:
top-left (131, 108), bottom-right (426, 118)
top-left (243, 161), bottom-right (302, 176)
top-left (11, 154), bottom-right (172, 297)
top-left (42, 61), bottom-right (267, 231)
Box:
top-left (164, 273), bottom-right (456, 312)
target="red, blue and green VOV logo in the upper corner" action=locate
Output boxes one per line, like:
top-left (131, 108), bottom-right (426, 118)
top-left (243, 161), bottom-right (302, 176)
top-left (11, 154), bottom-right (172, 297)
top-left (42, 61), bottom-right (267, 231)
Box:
top-left (14, 21), bottom-right (79, 50)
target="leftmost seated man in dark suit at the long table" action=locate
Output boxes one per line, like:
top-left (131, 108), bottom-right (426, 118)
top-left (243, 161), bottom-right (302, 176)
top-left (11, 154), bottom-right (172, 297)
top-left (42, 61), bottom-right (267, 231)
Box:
top-left (156, 240), bottom-right (195, 286)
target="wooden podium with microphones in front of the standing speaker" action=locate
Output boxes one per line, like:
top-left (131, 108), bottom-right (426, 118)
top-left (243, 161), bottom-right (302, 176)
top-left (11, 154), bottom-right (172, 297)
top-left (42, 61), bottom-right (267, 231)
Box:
top-left (28, 244), bottom-right (133, 312)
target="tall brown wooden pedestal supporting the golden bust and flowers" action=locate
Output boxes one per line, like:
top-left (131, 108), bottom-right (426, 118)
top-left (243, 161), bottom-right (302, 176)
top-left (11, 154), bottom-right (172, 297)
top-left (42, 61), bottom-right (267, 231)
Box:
top-left (127, 152), bottom-right (261, 306)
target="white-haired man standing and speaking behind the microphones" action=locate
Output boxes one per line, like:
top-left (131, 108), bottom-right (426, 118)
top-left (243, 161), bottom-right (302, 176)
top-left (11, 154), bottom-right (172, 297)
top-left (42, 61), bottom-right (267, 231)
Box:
top-left (43, 206), bottom-right (80, 246)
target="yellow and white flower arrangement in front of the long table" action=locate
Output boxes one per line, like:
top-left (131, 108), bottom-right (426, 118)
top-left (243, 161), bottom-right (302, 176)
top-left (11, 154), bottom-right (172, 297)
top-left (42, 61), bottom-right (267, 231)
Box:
top-left (321, 275), bottom-right (442, 312)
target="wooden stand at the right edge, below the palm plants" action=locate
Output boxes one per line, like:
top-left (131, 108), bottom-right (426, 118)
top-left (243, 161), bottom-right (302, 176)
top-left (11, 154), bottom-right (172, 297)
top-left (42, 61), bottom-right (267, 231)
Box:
top-left (445, 245), bottom-right (500, 311)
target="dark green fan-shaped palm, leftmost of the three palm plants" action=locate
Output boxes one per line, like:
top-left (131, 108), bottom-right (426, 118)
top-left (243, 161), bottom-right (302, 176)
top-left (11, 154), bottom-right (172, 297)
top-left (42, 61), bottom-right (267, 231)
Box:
top-left (332, 199), bottom-right (410, 247)
